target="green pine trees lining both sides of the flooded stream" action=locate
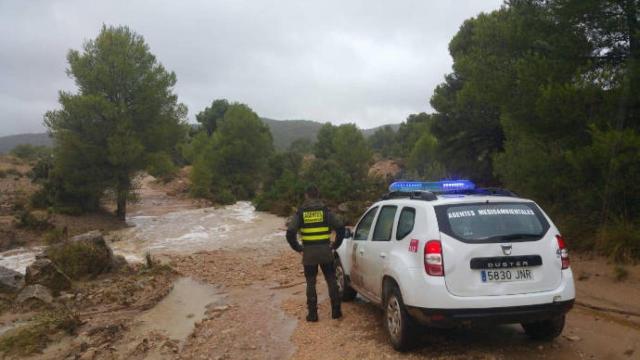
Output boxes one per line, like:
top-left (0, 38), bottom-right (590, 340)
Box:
top-left (33, 0), bottom-right (640, 260)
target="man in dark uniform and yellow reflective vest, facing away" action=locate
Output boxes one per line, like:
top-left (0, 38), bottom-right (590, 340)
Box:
top-left (287, 185), bottom-right (344, 322)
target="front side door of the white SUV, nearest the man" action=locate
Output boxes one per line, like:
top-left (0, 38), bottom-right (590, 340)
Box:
top-left (349, 206), bottom-right (378, 289)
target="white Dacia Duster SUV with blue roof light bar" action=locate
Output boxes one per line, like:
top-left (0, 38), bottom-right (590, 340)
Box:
top-left (336, 180), bottom-right (575, 351)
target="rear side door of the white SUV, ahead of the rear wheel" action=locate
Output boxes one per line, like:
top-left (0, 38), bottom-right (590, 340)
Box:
top-left (363, 205), bottom-right (398, 299)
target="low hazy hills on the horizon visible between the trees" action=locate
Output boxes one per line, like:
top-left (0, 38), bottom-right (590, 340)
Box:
top-left (0, 118), bottom-right (400, 154)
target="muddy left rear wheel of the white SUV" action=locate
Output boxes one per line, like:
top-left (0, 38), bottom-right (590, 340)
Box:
top-left (383, 284), bottom-right (416, 352)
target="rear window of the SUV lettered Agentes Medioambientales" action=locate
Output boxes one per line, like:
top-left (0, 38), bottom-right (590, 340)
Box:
top-left (436, 202), bottom-right (549, 243)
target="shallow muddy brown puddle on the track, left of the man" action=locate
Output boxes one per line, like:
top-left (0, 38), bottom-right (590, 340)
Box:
top-left (132, 277), bottom-right (223, 342)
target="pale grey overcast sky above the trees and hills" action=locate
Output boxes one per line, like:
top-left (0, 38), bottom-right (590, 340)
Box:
top-left (0, 0), bottom-right (502, 136)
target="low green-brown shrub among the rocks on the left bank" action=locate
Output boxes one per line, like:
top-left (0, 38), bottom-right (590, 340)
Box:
top-left (45, 241), bottom-right (112, 280)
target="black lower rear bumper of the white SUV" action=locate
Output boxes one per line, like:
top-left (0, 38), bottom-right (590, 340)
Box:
top-left (407, 300), bottom-right (574, 325)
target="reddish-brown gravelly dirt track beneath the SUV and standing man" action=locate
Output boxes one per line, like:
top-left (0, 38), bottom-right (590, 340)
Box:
top-left (132, 178), bottom-right (640, 359)
